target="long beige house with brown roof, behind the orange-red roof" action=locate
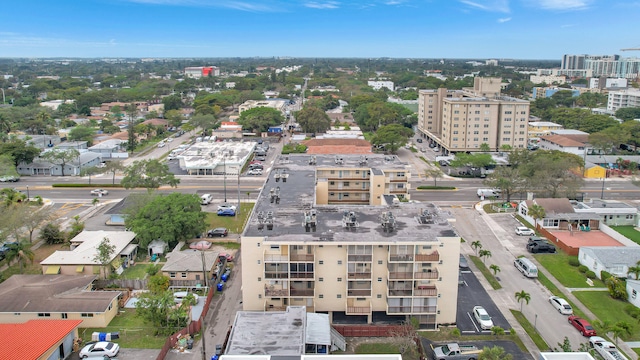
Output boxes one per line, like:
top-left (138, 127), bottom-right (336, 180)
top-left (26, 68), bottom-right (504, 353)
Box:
top-left (0, 275), bottom-right (121, 328)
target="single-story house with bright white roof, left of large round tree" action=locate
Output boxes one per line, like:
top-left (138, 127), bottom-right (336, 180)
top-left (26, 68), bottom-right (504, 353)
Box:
top-left (40, 230), bottom-right (138, 275)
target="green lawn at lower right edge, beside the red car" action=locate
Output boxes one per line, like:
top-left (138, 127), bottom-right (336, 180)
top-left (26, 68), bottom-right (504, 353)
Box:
top-left (573, 291), bottom-right (640, 341)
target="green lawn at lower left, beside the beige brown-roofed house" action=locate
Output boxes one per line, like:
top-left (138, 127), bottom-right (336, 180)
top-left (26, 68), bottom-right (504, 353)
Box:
top-left (78, 309), bottom-right (167, 349)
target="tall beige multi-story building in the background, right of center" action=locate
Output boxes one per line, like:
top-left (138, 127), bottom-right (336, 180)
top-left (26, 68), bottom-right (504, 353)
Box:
top-left (418, 77), bottom-right (529, 154)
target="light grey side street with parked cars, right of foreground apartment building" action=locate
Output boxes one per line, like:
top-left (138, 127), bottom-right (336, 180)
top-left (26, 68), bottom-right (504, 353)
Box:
top-left (452, 209), bottom-right (587, 348)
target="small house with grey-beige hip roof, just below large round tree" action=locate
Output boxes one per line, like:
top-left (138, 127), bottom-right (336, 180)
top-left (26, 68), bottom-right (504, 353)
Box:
top-left (161, 249), bottom-right (219, 286)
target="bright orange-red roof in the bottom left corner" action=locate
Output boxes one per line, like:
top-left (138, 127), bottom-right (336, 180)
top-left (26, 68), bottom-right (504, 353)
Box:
top-left (0, 320), bottom-right (82, 360)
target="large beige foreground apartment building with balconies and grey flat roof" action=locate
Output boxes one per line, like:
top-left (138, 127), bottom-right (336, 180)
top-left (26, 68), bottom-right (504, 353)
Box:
top-left (242, 155), bottom-right (460, 329)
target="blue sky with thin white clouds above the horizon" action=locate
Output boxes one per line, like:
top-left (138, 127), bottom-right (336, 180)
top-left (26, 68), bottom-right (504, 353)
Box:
top-left (0, 0), bottom-right (640, 60)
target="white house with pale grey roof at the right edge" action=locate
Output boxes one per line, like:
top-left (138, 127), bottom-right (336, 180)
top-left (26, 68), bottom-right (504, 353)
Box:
top-left (578, 246), bottom-right (640, 278)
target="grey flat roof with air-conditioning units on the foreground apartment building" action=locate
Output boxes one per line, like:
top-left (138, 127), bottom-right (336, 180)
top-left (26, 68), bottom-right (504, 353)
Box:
top-left (243, 155), bottom-right (458, 243)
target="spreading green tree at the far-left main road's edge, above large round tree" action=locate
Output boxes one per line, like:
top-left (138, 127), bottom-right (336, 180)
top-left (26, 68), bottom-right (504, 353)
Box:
top-left (120, 159), bottom-right (180, 190)
